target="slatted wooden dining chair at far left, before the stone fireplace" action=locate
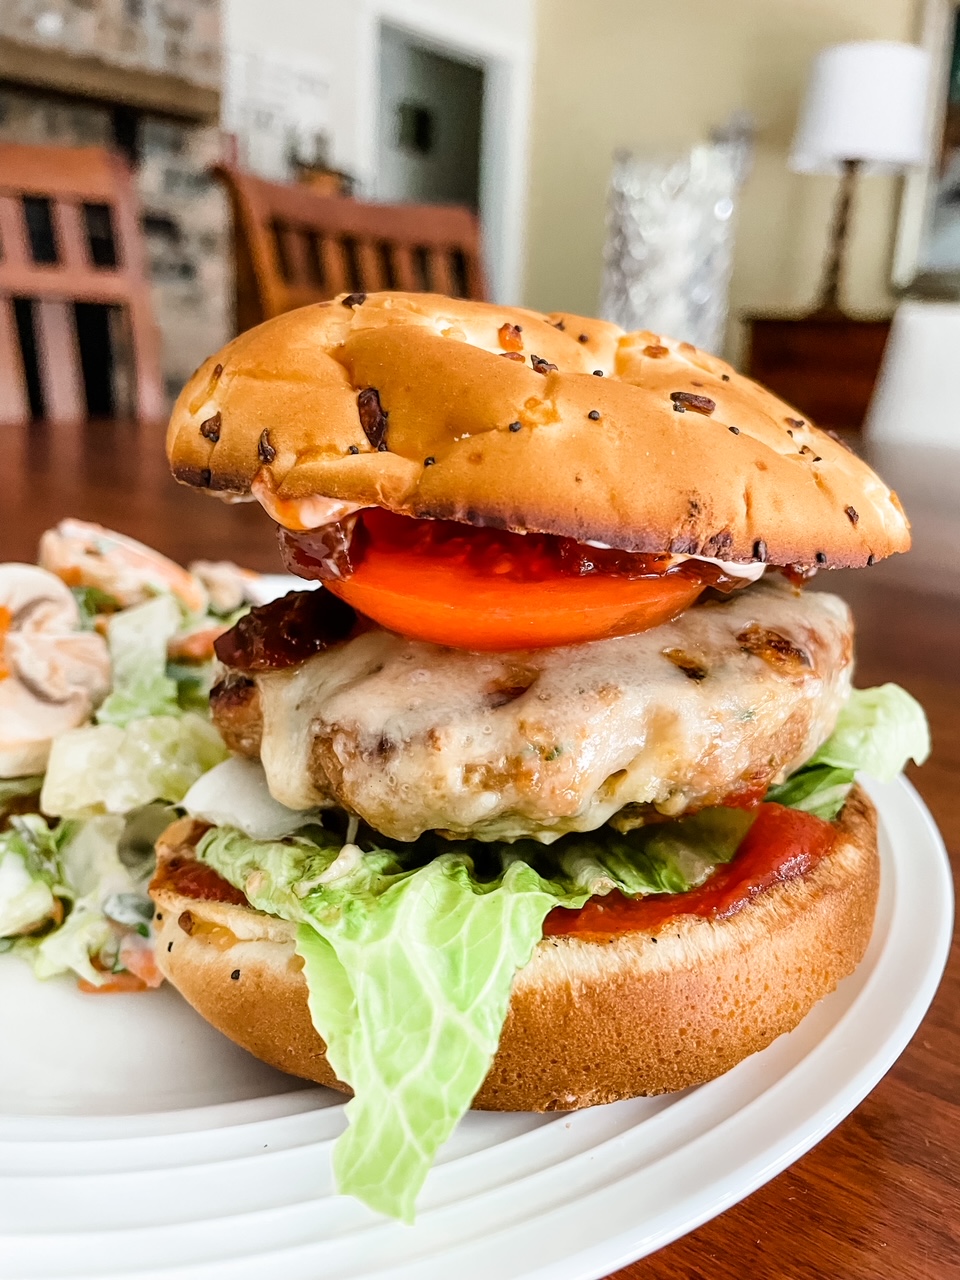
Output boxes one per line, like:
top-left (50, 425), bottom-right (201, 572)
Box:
top-left (0, 143), bottom-right (164, 422)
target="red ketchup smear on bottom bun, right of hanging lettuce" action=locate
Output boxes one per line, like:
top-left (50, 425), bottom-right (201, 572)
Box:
top-left (544, 804), bottom-right (837, 938)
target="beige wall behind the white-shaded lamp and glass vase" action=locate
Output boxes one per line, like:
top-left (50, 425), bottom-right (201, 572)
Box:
top-left (526, 0), bottom-right (915, 353)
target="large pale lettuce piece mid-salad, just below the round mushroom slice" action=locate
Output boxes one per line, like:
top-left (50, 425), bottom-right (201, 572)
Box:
top-left (40, 716), bottom-right (227, 817)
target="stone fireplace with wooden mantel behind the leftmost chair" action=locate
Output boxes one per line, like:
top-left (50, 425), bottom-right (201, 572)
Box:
top-left (0, 0), bottom-right (233, 399)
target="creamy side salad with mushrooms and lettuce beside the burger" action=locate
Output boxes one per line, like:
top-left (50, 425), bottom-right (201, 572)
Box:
top-left (0, 520), bottom-right (264, 992)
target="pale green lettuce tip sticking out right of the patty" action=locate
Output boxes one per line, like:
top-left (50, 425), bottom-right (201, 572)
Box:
top-left (767, 685), bottom-right (931, 820)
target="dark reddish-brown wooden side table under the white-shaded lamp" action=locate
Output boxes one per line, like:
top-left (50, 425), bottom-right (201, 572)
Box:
top-left (744, 314), bottom-right (890, 431)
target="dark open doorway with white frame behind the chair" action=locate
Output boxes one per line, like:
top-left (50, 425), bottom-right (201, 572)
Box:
top-left (376, 23), bottom-right (484, 212)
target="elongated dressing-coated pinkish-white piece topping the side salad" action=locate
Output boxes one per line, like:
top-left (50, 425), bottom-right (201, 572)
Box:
top-left (37, 520), bottom-right (207, 613)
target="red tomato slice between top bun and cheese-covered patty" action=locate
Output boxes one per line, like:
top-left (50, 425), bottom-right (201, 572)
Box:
top-left (316, 512), bottom-right (707, 649)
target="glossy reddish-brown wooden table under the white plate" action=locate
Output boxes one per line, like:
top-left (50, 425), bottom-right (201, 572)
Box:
top-left (0, 424), bottom-right (960, 1280)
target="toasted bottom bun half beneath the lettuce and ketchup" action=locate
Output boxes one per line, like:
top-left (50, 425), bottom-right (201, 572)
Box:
top-left (151, 788), bottom-right (879, 1111)
